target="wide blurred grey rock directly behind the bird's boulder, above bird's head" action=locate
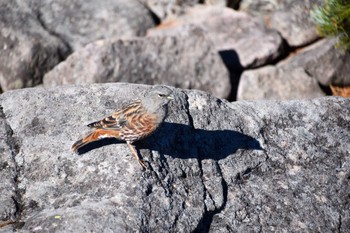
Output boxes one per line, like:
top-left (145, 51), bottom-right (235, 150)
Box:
top-left (44, 31), bottom-right (231, 98)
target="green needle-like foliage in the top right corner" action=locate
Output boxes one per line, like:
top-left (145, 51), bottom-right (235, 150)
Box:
top-left (311, 0), bottom-right (350, 49)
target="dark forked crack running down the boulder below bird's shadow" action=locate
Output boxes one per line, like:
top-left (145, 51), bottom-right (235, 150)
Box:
top-left (193, 161), bottom-right (228, 233)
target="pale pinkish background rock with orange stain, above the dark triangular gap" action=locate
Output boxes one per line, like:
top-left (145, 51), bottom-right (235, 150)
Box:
top-left (147, 5), bottom-right (282, 67)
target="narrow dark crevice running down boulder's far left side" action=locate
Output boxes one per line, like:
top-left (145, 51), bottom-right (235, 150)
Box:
top-left (0, 105), bottom-right (24, 229)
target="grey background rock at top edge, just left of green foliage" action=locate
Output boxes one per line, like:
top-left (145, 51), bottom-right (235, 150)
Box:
top-left (240, 0), bottom-right (323, 47)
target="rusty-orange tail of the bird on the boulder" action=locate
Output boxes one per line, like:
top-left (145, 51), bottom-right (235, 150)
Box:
top-left (72, 129), bottom-right (119, 152)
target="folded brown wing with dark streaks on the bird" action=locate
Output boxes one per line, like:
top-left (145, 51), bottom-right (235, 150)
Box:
top-left (87, 101), bottom-right (141, 129)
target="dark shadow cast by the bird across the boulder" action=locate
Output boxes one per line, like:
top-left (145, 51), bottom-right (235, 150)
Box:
top-left (79, 122), bottom-right (263, 160)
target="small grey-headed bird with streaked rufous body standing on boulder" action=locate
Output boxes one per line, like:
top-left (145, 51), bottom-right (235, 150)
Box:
top-left (72, 85), bottom-right (174, 169)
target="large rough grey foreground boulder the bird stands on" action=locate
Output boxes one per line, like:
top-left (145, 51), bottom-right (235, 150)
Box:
top-left (0, 84), bottom-right (350, 232)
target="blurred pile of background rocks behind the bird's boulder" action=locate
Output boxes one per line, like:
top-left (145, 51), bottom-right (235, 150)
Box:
top-left (0, 0), bottom-right (350, 97)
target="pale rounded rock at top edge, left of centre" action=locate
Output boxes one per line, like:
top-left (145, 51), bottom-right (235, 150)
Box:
top-left (29, 0), bottom-right (155, 51)
